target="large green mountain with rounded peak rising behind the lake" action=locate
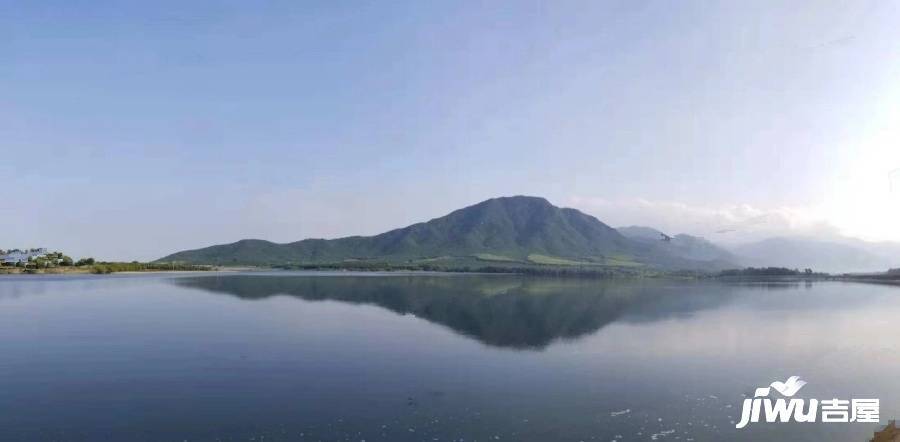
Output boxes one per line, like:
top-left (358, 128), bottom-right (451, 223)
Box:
top-left (159, 196), bottom-right (721, 269)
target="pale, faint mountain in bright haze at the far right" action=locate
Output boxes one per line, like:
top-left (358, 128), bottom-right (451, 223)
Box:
top-left (732, 237), bottom-right (900, 273)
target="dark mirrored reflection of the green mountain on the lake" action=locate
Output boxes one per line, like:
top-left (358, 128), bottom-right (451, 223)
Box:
top-left (173, 275), bottom-right (736, 349)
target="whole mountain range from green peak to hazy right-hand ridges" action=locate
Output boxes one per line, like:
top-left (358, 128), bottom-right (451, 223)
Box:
top-left (159, 196), bottom-right (900, 272)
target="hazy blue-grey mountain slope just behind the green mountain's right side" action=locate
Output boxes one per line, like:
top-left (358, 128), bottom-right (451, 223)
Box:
top-left (616, 226), bottom-right (739, 265)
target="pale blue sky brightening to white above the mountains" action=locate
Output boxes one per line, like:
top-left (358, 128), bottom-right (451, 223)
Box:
top-left (0, 1), bottom-right (900, 259)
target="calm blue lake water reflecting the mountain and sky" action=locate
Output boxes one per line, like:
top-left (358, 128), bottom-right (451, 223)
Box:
top-left (0, 273), bottom-right (900, 442)
